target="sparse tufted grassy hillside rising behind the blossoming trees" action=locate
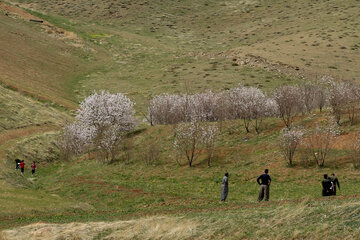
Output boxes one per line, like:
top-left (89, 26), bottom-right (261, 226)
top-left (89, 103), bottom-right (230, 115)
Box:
top-left (2, 0), bottom-right (360, 109)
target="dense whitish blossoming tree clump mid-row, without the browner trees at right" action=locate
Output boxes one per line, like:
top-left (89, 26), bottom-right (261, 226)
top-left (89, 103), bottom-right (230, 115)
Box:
top-left (149, 87), bottom-right (278, 132)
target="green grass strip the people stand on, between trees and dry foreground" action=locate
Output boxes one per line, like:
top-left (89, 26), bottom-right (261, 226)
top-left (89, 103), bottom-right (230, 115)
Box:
top-left (0, 113), bottom-right (360, 234)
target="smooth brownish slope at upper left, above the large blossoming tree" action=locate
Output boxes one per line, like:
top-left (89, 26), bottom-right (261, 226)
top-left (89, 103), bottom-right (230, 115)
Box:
top-left (0, 7), bottom-right (91, 108)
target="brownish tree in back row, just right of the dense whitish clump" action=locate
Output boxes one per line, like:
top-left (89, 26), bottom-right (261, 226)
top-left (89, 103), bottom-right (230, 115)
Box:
top-left (273, 86), bottom-right (304, 128)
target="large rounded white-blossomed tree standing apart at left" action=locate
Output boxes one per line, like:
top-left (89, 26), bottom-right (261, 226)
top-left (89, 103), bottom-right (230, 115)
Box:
top-left (64, 91), bottom-right (135, 161)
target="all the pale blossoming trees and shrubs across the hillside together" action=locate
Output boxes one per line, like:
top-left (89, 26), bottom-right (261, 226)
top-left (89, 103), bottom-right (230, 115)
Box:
top-left (60, 76), bottom-right (360, 166)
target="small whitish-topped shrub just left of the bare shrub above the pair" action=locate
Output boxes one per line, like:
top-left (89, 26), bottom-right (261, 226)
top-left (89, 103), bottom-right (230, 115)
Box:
top-left (279, 128), bottom-right (304, 166)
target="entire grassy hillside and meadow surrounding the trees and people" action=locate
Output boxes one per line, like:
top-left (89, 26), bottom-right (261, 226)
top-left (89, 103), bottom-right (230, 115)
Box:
top-left (0, 0), bottom-right (360, 240)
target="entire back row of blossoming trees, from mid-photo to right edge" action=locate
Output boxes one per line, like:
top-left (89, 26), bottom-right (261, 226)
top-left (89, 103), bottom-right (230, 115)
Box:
top-left (149, 76), bottom-right (360, 132)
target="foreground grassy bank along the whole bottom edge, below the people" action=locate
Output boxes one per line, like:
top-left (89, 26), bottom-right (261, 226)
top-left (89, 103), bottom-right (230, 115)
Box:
top-left (1, 199), bottom-right (360, 240)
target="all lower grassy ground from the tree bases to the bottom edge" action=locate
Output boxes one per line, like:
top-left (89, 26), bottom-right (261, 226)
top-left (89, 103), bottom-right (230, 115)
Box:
top-left (0, 113), bottom-right (360, 239)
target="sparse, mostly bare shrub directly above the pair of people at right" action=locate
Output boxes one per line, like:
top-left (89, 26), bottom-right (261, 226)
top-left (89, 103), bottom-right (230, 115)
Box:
top-left (305, 118), bottom-right (339, 167)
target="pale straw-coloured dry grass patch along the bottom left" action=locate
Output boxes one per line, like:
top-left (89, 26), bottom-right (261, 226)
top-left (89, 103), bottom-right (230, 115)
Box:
top-left (3, 217), bottom-right (199, 240)
